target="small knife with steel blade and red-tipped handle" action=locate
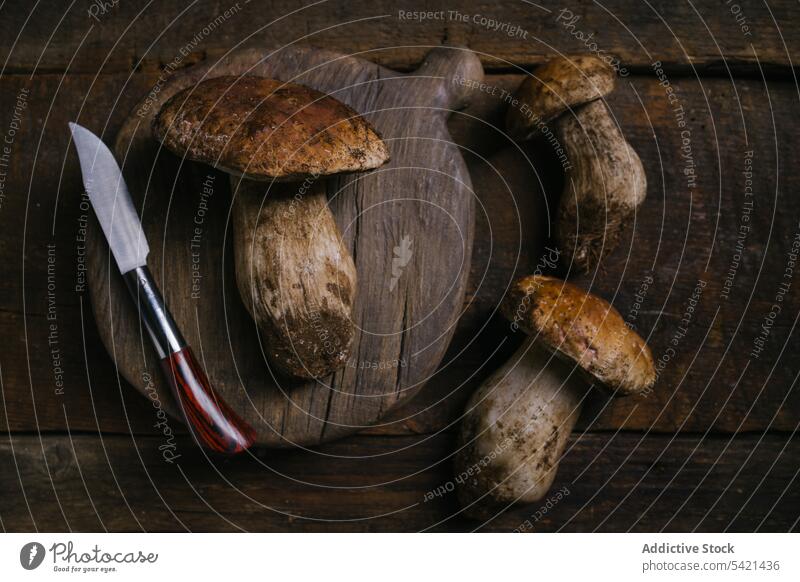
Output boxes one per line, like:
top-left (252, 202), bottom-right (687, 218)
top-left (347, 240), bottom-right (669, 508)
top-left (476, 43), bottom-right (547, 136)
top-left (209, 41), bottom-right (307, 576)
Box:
top-left (69, 123), bottom-right (255, 454)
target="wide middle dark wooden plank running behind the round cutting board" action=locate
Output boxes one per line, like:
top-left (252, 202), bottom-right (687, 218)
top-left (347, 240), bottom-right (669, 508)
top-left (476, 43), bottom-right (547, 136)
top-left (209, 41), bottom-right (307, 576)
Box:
top-left (0, 74), bottom-right (800, 434)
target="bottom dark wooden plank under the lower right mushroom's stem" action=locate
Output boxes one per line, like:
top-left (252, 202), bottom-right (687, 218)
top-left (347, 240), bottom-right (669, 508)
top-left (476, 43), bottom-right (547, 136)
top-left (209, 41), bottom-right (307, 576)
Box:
top-left (0, 433), bottom-right (800, 531)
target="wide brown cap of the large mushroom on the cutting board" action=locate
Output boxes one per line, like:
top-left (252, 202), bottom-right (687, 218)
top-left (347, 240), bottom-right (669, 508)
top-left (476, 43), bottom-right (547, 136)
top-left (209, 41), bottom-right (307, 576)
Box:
top-left (153, 76), bottom-right (389, 181)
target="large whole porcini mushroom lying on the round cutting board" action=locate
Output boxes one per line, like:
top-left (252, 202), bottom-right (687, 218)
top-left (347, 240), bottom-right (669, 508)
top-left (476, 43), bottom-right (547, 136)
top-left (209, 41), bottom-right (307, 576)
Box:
top-left (153, 76), bottom-right (389, 378)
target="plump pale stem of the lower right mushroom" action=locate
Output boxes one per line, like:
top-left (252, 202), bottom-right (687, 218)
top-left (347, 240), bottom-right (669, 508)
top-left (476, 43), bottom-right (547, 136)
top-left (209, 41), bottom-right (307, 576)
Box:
top-left (455, 339), bottom-right (588, 516)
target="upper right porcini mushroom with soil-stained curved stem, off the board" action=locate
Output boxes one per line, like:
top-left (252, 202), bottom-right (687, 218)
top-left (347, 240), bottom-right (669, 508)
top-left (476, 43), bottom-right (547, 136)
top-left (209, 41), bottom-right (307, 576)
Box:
top-left (506, 56), bottom-right (647, 271)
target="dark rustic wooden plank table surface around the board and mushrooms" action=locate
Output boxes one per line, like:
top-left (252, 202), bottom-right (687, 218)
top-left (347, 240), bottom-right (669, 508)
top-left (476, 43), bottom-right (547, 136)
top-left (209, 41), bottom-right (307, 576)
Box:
top-left (0, 0), bottom-right (800, 531)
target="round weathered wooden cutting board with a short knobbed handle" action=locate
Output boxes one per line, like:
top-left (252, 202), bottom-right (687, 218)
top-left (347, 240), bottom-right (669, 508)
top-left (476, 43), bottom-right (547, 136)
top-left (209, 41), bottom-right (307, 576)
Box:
top-left (87, 47), bottom-right (483, 447)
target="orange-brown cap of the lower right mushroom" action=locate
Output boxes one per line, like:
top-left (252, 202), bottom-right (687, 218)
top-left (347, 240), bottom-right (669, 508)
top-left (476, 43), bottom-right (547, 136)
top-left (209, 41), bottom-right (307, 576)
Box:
top-left (501, 275), bottom-right (656, 395)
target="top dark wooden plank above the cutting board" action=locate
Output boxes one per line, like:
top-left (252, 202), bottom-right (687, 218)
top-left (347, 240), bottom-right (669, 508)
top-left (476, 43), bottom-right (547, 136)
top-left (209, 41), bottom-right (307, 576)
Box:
top-left (0, 0), bottom-right (800, 75)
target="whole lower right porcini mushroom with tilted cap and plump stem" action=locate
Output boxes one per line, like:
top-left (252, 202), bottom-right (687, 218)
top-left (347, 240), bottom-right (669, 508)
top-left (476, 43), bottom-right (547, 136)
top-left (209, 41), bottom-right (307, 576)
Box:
top-left (455, 275), bottom-right (656, 515)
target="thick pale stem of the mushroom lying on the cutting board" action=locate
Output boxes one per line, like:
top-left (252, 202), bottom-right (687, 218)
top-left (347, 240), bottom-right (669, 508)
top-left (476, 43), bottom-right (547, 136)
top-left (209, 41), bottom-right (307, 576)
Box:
top-left (232, 179), bottom-right (356, 378)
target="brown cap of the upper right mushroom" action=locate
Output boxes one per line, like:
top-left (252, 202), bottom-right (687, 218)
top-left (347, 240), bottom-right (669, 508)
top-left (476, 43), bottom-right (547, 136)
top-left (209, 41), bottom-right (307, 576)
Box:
top-left (506, 56), bottom-right (617, 140)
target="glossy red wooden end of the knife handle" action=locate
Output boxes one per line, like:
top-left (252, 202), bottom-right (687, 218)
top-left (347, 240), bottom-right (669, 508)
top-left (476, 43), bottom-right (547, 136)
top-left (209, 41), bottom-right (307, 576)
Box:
top-left (161, 347), bottom-right (256, 454)
